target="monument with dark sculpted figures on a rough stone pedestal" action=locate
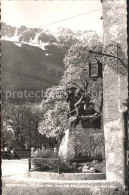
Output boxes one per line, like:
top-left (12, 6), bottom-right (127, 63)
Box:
top-left (59, 87), bottom-right (104, 165)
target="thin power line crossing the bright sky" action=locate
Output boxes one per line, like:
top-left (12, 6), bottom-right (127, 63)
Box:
top-left (41, 8), bottom-right (102, 28)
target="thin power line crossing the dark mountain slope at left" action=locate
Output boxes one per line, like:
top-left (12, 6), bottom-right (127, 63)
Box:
top-left (1, 67), bottom-right (58, 84)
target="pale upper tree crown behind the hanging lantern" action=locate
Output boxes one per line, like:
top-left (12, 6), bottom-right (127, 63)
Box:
top-left (60, 40), bottom-right (102, 110)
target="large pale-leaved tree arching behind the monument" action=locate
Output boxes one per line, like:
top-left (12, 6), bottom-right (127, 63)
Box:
top-left (39, 32), bottom-right (102, 137)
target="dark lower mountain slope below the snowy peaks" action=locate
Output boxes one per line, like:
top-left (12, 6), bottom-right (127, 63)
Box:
top-left (2, 40), bottom-right (65, 95)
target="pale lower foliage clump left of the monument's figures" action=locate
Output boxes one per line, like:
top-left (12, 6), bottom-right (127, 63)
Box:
top-left (38, 85), bottom-right (68, 137)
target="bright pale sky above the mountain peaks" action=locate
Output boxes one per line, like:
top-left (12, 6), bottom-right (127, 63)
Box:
top-left (1, 0), bottom-right (102, 34)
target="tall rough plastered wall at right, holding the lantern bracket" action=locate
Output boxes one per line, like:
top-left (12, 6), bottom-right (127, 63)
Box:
top-left (102, 0), bottom-right (128, 186)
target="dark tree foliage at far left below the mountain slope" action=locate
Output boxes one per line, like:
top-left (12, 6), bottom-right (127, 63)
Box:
top-left (2, 104), bottom-right (41, 148)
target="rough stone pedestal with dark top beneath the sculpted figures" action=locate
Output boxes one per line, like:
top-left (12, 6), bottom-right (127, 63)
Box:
top-left (58, 116), bottom-right (104, 162)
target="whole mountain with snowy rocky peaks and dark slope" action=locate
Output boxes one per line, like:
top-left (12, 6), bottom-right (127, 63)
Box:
top-left (1, 22), bottom-right (100, 102)
